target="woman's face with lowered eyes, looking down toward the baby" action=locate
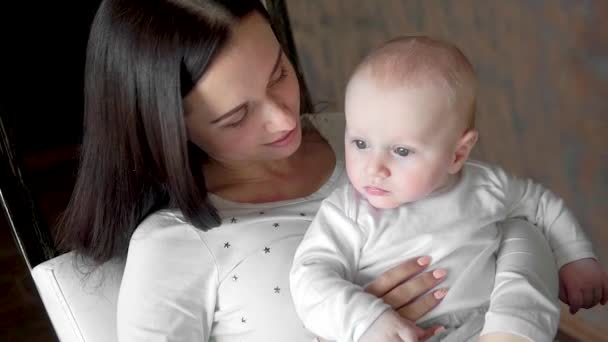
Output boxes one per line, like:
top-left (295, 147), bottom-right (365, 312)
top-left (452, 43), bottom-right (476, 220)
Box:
top-left (184, 13), bottom-right (302, 164)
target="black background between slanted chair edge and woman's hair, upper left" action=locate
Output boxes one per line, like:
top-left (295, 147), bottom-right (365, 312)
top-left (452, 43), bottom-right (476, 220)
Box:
top-left (0, 0), bottom-right (100, 231)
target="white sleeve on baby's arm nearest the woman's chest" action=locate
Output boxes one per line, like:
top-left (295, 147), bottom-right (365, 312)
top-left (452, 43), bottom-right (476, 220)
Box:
top-left (290, 189), bottom-right (390, 341)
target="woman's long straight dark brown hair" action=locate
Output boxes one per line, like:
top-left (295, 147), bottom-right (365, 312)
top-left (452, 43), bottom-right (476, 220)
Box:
top-left (59, 0), bottom-right (268, 263)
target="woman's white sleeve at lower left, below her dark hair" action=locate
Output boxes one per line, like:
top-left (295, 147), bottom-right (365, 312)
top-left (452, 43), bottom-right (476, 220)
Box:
top-left (117, 217), bottom-right (219, 342)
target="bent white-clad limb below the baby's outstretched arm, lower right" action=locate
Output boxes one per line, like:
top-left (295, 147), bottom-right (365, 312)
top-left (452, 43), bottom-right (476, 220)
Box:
top-left (481, 219), bottom-right (560, 341)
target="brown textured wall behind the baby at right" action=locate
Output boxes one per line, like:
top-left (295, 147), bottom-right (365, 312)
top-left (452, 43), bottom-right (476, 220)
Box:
top-left (287, 0), bottom-right (608, 336)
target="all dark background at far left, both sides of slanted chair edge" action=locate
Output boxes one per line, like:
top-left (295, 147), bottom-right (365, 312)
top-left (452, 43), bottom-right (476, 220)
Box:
top-left (0, 0), bottom-right (99, 342)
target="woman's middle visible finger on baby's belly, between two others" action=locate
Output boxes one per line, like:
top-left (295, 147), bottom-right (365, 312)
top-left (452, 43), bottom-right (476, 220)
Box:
top-left (382, 270), bottom-right (446, 309)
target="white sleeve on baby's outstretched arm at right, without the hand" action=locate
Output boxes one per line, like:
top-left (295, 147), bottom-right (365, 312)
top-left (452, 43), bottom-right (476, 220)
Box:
top-left (495, 164), bottom-right (597, 268)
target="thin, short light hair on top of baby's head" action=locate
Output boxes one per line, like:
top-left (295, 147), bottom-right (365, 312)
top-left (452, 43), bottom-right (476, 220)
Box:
top-left (349, 36), bottom-right (477, 130)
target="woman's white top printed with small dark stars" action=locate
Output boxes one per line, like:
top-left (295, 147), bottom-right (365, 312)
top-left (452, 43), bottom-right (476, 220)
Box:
top-left (117, 114), bottom-right (347, 342)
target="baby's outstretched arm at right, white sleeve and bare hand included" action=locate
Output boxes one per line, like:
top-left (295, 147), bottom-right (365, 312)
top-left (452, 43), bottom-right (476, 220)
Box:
top-left (498, 164), bottom-right (608, 312)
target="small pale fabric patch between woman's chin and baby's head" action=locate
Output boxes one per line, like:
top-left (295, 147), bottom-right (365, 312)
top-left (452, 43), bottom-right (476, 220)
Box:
top-left (303, 112), bottom-right (346, 160)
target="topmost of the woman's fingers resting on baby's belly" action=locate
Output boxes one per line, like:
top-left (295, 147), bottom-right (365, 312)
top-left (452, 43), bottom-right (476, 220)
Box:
top-left (365, 256), bottom-right (431, 298)
